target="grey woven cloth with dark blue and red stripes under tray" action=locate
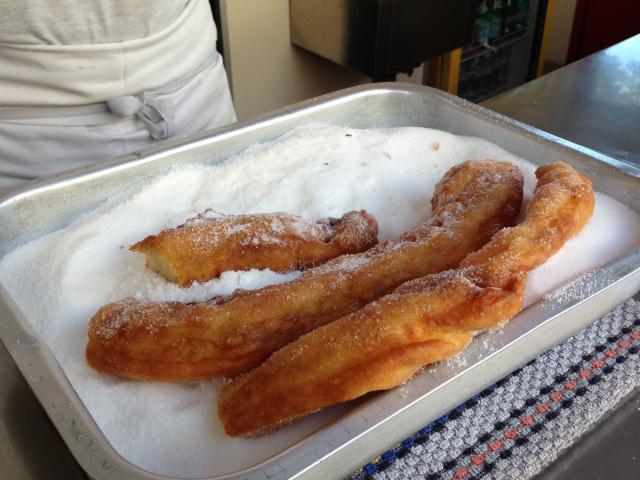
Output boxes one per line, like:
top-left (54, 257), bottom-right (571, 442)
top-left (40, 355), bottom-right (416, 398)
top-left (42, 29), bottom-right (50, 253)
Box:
top-left (349, 300), bottom-right (640, 480)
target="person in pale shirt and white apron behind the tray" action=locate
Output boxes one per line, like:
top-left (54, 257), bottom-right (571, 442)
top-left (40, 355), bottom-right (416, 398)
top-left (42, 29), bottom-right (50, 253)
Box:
top-left (0, 0), bottom-right (235, 191)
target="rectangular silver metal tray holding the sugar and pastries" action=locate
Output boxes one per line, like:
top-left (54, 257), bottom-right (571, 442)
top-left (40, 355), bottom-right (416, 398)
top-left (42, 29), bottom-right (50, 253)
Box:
top-left (0, 83), bottom-right (640, 480)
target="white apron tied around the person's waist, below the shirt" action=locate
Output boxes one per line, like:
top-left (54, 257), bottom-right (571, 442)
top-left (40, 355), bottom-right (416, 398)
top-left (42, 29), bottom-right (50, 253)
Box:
top-left (0, 0), bottom-right (235, 194)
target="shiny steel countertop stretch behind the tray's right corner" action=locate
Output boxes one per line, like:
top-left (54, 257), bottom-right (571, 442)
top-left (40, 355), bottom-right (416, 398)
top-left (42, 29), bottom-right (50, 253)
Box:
top-left (483, 35), bottom-right (640, 164)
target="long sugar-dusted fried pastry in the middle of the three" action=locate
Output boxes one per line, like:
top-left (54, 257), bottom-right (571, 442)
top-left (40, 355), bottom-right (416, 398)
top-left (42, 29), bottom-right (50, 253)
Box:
top-left (86, 160), bottom-right (523, 381)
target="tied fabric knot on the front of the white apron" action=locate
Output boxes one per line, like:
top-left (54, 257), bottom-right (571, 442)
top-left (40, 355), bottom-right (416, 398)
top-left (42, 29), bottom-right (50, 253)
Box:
top-left (107, 92), bottom-right (174, 140)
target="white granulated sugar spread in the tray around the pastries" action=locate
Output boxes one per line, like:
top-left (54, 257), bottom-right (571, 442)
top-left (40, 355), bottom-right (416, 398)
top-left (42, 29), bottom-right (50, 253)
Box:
top-left (0, 126), bottom-right (640, 477)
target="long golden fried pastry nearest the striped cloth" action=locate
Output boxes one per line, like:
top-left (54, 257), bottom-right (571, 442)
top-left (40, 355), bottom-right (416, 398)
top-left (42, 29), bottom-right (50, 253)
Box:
top-left (219, 163), bottom-right (594, 436)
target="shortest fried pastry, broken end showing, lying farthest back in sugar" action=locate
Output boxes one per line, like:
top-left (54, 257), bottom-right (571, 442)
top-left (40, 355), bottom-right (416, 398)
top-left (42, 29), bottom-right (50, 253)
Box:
top-left (130, 210), bottom-right (378, 287)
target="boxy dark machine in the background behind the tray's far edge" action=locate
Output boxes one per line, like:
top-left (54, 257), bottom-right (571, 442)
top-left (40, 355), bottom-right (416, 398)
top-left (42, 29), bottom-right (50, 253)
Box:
top-left (290, 0), bottom-right (477, 81)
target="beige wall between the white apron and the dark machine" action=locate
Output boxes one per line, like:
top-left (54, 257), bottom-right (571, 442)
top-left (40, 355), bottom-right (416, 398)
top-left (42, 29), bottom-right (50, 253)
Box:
top-left (220, 0), bottom-right (371, 120)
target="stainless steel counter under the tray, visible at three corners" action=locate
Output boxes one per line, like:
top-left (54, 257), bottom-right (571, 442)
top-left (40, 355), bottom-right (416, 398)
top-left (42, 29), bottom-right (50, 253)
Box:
top-left (0, 36), bottom-right (640, 480)
